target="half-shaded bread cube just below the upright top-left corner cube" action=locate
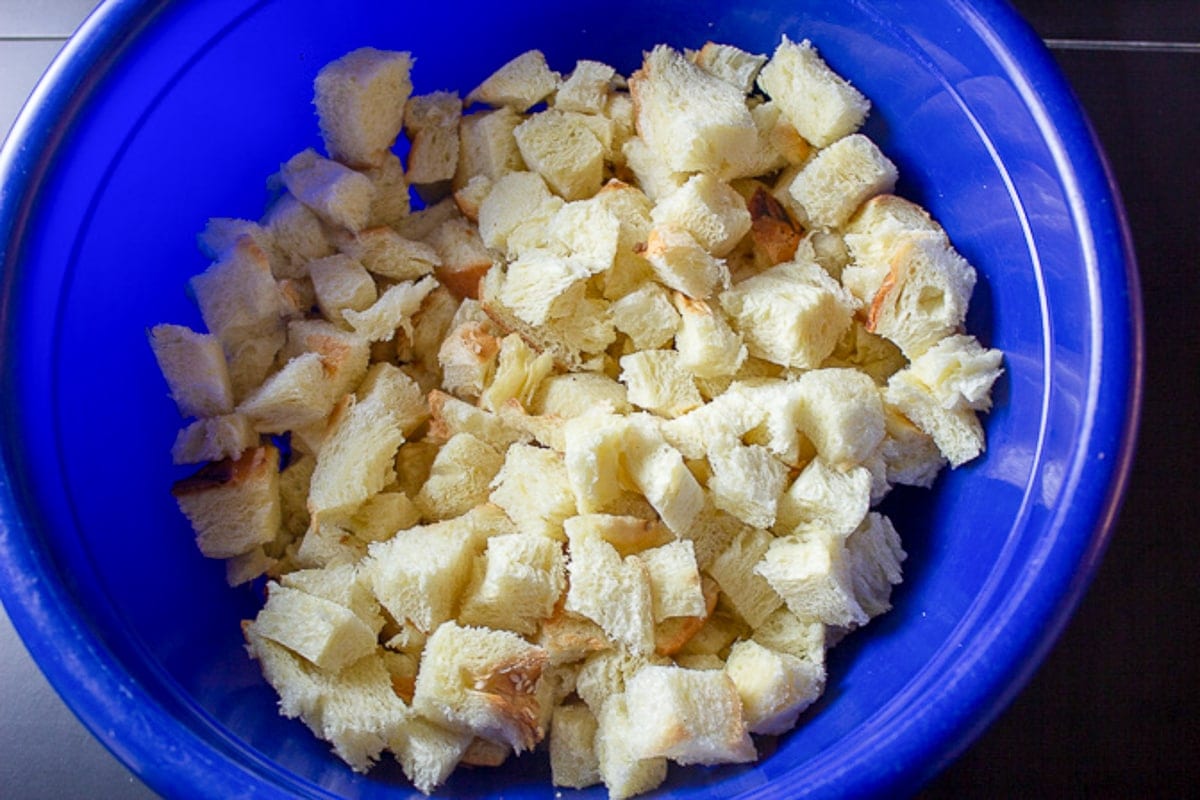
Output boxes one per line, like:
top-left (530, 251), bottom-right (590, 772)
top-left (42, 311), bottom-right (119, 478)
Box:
top-left (281, 149), bottom-right (377, 233)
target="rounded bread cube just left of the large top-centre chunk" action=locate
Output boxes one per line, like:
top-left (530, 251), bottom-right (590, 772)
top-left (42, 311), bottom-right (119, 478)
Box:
top-left (512, 108), bottom-right (605, 200)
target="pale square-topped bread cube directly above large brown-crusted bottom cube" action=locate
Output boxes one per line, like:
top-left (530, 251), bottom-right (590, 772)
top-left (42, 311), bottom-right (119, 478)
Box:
top-left (458, 533), bottom-right (566, 634)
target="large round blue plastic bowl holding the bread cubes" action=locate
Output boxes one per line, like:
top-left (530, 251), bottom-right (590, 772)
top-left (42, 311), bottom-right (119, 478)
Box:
top-left (0, 0), bottom-right (1141, 798)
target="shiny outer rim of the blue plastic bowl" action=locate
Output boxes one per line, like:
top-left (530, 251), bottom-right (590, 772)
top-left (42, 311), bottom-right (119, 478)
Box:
top-left (0, 0), bottom-right (1144, 796)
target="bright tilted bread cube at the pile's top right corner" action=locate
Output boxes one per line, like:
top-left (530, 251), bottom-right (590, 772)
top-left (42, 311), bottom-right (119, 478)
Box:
top-left (758, 36), bottom-right (870, 148)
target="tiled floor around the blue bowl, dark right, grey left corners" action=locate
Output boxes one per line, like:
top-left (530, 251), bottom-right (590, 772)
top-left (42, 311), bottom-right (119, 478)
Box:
top-left (7, 0), bottom-right (1200, 800)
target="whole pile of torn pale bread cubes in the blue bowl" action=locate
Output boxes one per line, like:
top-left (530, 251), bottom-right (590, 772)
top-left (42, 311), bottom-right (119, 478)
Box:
top-left (150, 37), bottom-right (1001, 798)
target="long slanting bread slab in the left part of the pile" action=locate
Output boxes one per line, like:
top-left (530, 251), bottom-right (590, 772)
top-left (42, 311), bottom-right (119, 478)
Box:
top-left (308, 365), bottom-right (425, 519)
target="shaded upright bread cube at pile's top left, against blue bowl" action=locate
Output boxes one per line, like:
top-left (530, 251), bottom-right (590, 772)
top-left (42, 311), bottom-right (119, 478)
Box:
top-left (312, 47), bottom-right (413, 167)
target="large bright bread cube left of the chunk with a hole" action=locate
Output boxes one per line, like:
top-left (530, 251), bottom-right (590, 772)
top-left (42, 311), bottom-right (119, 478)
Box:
top-left (719, 261), bottom-right (856, 369)
